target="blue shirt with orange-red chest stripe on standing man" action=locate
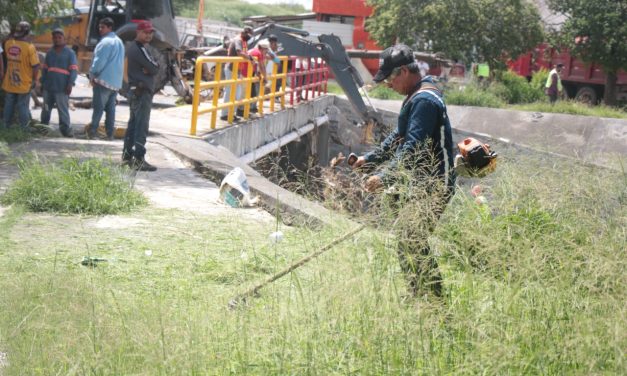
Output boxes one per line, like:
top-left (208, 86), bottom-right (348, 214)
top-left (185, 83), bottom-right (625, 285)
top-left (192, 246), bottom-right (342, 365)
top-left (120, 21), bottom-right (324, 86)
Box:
top-left (41, 46), bottom-right (78, 93)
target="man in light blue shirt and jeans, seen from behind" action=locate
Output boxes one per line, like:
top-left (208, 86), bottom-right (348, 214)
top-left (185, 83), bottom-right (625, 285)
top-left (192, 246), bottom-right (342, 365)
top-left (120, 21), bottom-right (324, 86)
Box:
top-left (87, 17), bottom-right (124, 140)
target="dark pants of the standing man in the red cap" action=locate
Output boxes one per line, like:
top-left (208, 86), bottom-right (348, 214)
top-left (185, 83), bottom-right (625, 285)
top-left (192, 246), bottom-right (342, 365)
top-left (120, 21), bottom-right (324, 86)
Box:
top-left (122, 90), bottom-right (152, 161)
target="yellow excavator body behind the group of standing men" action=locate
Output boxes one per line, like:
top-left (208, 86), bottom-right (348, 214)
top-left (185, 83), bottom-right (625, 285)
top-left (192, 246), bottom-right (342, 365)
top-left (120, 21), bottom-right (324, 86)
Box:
top-left (33, 0), bottom-right (191, 99)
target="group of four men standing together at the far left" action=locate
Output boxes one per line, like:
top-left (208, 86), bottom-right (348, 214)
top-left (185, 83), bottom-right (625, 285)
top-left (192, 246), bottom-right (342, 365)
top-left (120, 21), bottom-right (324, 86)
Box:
top-left (0, 17), bottom-right (159, 171)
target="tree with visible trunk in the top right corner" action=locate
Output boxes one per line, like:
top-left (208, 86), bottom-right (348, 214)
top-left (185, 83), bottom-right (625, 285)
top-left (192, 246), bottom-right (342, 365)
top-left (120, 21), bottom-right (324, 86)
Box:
top-left (549, 0), bottom-right (627, 105)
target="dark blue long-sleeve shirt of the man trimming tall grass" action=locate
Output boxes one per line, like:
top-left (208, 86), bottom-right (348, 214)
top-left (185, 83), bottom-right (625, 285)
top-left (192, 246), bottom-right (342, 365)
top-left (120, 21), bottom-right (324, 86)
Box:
top-left (365, 77), bottom-right (455, 188)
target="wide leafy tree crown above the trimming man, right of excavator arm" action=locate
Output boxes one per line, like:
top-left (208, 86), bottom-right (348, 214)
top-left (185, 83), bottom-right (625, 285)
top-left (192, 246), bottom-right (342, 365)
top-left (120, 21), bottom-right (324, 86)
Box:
top-left (367, 0), bottom-right (543, 67)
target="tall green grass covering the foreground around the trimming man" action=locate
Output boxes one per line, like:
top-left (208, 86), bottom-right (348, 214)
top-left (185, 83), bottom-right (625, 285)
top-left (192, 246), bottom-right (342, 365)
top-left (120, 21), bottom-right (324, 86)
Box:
top-left (0, 145), bottom-right (627, 375)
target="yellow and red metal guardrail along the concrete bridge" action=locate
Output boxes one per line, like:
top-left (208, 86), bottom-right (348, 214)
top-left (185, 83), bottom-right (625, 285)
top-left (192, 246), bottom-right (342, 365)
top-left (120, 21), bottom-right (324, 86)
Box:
top-left (189, 56), bottom-right (329, 136)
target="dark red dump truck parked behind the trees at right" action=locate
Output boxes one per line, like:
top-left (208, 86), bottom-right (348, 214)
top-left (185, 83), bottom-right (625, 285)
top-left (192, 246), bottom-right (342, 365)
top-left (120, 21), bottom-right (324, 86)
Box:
top-left (508, 44), bottom-right (627, 103)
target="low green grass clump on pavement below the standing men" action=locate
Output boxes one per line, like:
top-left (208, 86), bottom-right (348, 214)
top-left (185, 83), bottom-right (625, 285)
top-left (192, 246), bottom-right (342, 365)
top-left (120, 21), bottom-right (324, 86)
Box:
top-left (0, 156), bottom-right (146, 215)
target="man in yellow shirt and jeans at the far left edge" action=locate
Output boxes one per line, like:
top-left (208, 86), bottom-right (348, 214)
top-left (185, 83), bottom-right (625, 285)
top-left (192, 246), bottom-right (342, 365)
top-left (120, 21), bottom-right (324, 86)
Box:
top-left (2, 21), bottom-right (39, 130)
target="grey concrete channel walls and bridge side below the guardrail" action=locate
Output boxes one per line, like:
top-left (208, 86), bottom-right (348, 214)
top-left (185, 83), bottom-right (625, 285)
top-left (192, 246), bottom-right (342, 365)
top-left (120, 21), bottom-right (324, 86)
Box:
top-left (156, 95), bottom-right (627, 228)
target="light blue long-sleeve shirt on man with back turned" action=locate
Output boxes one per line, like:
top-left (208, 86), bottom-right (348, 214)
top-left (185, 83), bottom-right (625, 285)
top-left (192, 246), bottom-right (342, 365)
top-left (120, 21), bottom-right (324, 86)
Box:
top-left (89, 32), bottom-right (124, 90)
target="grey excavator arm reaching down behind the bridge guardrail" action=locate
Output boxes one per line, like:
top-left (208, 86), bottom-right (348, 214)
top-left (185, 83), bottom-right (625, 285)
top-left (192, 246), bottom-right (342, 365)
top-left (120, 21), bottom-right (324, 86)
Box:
top-left (249, 23), bottom-right (381, 123)
